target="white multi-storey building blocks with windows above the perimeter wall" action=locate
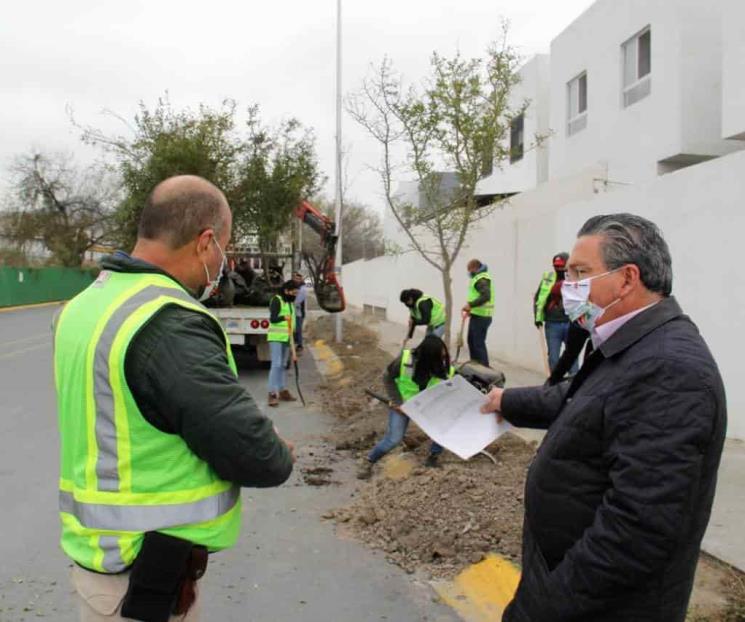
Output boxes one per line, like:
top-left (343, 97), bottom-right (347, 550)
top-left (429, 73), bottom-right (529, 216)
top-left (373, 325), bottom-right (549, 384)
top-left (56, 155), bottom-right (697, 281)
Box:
top-left (479, 0), bottom-right (745, 194)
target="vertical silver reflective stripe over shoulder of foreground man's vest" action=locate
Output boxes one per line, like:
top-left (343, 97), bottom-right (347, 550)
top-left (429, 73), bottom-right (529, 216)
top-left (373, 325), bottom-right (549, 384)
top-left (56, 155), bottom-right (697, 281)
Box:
top-left (93, 285), bottom-right (201, 492)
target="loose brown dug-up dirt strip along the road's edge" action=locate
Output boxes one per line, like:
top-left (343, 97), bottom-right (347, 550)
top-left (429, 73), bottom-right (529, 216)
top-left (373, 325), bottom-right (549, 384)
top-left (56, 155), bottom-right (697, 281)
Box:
top-left (311, 317), bottom-right (535, 576)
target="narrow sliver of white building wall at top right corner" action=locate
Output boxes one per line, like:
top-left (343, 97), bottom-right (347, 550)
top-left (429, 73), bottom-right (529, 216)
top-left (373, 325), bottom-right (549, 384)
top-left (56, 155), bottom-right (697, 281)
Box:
top-left (722, 0), bottom-right (745, 139)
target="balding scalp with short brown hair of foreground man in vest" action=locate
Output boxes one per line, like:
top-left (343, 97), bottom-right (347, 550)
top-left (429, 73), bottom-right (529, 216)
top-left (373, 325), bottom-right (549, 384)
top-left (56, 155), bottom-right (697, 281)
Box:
top-left (137, 175), bottom-right (230, 249)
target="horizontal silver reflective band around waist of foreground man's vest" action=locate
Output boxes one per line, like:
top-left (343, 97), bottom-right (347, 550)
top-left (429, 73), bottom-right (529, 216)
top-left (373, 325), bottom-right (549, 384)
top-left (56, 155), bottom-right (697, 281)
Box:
top-left (59, 486), bottom-right (240, 531)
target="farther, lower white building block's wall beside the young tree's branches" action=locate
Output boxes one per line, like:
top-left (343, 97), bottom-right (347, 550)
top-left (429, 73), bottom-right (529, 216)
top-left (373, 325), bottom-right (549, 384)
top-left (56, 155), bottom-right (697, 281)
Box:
top-left (477, 54), bottom-right (550, 194)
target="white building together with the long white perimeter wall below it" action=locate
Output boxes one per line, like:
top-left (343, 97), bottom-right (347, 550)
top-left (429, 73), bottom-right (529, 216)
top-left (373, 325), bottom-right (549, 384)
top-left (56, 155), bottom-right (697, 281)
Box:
top-left (344, 0), bottom-right (745, 440)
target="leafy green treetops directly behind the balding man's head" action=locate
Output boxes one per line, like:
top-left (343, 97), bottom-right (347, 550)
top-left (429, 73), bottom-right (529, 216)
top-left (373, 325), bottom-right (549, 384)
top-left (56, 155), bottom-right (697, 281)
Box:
top-left (81, 96), bottom-right (319, 249)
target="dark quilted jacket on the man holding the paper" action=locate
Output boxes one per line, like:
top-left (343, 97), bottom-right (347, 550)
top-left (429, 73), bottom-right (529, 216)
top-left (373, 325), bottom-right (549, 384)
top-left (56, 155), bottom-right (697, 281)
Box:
top-left (502, 298), bottom-right (726, 622)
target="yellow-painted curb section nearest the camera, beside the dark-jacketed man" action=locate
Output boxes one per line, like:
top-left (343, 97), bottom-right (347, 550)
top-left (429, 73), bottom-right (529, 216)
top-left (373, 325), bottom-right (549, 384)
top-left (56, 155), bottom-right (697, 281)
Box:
top-left (432, 553), bottom-right (520, 622)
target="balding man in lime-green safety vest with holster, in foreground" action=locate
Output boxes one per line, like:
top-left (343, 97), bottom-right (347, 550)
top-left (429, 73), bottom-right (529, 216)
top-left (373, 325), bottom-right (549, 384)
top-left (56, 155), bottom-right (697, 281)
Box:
top-left (54, 176), bottom-right (294, 621)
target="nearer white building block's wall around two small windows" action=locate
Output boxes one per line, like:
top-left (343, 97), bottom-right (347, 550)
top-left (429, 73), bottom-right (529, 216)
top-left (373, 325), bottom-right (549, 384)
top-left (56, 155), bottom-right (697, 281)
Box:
top-left (549, 0), bottom-right (742, 183)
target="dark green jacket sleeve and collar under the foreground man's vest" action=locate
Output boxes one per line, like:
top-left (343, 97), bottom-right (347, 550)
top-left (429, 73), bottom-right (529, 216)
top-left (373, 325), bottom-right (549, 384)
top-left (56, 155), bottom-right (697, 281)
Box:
top-left (102, 253), bottom-right (292, 487)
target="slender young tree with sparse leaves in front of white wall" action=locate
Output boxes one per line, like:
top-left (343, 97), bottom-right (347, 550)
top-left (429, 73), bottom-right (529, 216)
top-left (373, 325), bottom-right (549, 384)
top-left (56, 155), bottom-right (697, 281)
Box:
top-left (347, 29), bottom-right (523, 340)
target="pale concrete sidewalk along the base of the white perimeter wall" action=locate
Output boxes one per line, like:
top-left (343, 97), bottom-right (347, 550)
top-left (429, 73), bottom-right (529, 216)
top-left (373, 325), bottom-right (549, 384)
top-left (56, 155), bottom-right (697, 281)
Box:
top-left (347, 307), bottom-right (745, 572)
